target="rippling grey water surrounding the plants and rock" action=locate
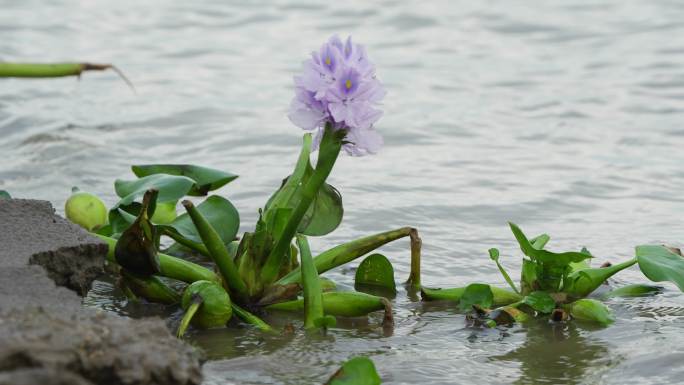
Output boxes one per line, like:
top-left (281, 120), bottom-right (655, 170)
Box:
top-left (0, 0), bottom-right (684, 384)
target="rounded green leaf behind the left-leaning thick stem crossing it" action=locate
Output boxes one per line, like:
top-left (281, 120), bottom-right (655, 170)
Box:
top-left (160, 195), bottom-right (240, 245)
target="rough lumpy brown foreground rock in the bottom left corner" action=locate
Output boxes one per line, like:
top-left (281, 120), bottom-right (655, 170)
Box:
top-left (0, 308), bottom-right (201, 385)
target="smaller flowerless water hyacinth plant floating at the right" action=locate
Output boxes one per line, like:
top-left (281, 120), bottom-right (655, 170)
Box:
top-left (421, 223), bottom-right (684, 327)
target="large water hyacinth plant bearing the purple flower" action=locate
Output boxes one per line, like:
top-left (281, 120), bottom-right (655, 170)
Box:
top-left (67, 37), bottom-right (421, 336)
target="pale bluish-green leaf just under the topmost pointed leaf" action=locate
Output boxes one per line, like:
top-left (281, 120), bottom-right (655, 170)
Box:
top-left (113, 174), bottom-right (195, 209)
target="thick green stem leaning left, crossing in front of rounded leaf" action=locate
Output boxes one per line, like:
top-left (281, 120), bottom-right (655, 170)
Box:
top-left (183, 200), bottom-right (249, 300)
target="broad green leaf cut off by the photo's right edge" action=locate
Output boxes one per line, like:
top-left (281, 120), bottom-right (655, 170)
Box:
top-left (636, 245), bottom-right (684, 291)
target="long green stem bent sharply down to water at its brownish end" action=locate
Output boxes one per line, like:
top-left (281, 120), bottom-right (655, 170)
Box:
top-left (276, 227), bottom-right (420, 285)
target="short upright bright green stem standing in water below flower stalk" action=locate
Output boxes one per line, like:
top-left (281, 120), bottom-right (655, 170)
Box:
top-left (297, 235), bottom-right (323, 329)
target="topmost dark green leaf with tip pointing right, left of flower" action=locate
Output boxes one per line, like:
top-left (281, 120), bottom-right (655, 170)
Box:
top-left (131, 164), bottom-right (238, 196)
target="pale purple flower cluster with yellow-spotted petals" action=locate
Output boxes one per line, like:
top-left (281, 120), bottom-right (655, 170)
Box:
top-left (288, 36), bottom-right (386, 156)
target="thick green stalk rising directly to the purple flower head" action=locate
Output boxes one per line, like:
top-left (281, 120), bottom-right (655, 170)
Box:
top-left (261, 124), bottom-right (342, 286)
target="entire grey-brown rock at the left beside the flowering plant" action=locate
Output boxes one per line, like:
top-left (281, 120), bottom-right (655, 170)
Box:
top-left (0, 200), bottom-right (201, 385)
